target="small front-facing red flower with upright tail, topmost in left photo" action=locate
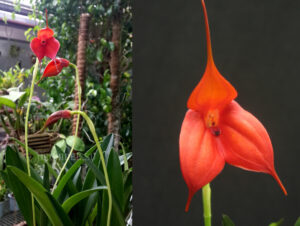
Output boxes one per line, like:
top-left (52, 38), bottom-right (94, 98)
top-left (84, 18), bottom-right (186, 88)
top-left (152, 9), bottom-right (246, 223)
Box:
top-left (30, 9), bottom-right (60, 61)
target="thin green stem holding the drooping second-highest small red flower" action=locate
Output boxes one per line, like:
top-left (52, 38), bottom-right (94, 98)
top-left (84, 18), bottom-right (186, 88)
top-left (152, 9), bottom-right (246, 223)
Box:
top-left (52, 63), bottom-right (81, 194)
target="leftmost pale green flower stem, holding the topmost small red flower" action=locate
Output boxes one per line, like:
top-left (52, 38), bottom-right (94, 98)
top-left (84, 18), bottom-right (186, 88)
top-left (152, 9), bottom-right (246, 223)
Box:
top-left (25, 58), bottom-right (39, 226)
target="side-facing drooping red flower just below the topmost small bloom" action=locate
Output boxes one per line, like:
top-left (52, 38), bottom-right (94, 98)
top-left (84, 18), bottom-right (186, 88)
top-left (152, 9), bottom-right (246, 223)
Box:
top-left (37, 58), bottom-right (70, 84)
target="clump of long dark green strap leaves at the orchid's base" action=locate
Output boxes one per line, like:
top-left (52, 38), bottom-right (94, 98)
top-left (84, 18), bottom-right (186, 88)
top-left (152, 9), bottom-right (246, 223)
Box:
top-left (1, 135), bottom-right (132, 226)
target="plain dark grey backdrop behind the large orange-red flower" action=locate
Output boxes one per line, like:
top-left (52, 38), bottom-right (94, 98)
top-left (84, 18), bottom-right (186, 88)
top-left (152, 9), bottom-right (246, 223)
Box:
top-left (133, 0), bottom-right (300, 226)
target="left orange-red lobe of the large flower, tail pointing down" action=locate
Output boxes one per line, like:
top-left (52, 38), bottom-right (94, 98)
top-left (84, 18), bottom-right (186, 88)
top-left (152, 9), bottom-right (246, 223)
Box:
top-left (179, 110), bottom-right (225, 211)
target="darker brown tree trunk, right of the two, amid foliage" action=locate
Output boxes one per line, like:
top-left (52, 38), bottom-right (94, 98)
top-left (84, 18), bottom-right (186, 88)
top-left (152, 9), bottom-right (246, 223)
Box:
top-left (107, 13), bottom-right (121, 151)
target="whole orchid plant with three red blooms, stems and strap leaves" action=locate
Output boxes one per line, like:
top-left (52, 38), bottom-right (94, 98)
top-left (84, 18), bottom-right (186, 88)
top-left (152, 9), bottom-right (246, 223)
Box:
top-left (1, 10), bottom-right (132, 226)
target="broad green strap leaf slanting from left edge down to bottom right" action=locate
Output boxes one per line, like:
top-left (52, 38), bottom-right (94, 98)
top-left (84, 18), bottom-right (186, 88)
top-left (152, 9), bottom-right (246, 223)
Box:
top-left (7, 166), bottom-right (72, 225)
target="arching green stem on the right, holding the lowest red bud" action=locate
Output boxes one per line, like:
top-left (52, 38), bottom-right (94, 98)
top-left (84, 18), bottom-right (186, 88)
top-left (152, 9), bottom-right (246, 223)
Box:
top-left (72, 111), bottom-right (112, 226)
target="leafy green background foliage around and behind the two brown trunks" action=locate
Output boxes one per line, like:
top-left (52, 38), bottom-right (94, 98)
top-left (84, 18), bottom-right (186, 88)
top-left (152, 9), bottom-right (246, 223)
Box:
top-left (25, 0), bottom-right (132, 149)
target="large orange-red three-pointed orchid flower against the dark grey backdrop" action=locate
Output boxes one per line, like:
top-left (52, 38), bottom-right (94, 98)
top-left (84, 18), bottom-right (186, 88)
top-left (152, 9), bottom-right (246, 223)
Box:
top-left (179, 0), bottom-right (287, 211)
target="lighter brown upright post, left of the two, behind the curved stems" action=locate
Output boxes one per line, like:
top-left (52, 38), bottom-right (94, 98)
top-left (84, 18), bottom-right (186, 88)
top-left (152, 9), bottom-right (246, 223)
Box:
top-left (72, 13), bottom-right (90, 137)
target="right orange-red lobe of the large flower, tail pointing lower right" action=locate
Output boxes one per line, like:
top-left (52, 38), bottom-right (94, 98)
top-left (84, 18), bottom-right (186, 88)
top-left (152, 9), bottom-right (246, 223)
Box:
top-left (220, 101), bottom-right (287, 194)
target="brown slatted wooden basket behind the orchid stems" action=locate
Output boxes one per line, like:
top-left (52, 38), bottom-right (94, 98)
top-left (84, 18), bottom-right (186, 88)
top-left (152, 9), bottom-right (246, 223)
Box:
top-left (21, 133), bottom-right (60, 154)
